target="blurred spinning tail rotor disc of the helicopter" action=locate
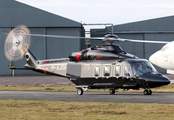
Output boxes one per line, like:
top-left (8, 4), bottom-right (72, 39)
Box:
top-left (4, 25), bottom-right (31, 61)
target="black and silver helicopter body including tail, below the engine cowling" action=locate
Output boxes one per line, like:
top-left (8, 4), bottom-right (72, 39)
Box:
top-left (25, 51), bottom-right (170, 93)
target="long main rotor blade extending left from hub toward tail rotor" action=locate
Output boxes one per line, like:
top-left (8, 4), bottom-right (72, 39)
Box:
top-left (17, 34), bottom-right (103, 40)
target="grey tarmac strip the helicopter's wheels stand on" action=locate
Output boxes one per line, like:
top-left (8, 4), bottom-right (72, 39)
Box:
top-left (0, 91), bottom-right (174, 104)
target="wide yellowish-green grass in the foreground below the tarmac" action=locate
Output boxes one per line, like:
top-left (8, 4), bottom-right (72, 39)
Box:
top-left (0, 100), bottom-right (174, 120)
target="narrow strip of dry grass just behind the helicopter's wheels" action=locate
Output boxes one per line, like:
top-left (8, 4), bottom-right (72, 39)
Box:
top-left (0, 84), bottom-right (174, 93)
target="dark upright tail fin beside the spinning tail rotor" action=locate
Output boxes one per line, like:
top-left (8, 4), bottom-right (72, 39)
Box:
top-left (25, 49), bottom-right (38, 68)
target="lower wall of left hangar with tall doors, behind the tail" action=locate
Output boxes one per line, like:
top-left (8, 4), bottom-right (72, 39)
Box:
top-left (0, 28), bottom-right (85, 76)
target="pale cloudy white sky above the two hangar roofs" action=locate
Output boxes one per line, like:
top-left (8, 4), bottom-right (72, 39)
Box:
top-left (16, 0), bottom-right (174, 29)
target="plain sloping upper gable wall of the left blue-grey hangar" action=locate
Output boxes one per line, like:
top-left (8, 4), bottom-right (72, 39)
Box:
top-left (0, 0), bottom-right (81, 27)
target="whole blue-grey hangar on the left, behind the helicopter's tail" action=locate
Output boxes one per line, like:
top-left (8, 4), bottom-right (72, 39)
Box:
top-left (0, 0), bottom-right (85, 76)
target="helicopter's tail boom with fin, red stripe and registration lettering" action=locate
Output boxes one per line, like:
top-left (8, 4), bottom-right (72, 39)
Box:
top-left (25, 50), bottom-right (69, 77)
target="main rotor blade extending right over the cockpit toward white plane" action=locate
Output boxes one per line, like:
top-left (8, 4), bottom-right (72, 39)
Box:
top-left (116, 38), bottom-right (170, 44)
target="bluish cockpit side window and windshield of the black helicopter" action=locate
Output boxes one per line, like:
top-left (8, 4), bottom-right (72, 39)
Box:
top-left (133, 61), bottom-right (157, 77)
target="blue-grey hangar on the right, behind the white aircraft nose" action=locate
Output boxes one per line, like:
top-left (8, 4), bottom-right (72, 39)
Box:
top-left (91, 16), bottom-right (174, 73)
